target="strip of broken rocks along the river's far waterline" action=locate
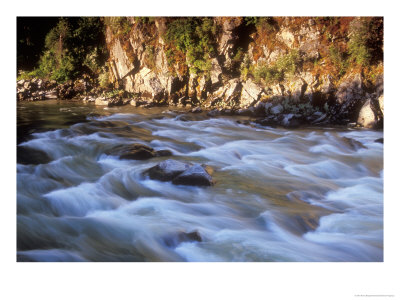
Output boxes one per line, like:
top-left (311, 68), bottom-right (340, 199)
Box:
top-left (17, 75), bottom-right (384, 129)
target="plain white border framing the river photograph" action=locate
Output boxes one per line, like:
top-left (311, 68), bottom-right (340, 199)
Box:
top-left (0, 0), bottom-right (400, 300)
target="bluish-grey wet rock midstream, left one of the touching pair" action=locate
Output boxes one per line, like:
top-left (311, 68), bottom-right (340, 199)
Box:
top-left (146, 159), bottom-right (191, 181)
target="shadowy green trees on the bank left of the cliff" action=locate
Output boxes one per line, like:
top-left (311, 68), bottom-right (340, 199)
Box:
top-left (19, 17), bottom-right (108, 83)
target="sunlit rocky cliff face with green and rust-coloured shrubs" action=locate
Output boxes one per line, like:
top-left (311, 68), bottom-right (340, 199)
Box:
top-left (106, 17), bottom-right (383, 126)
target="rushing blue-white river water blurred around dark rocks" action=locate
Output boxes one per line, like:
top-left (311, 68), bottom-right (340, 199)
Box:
top-left (17, 101), bottom-right (383, 262)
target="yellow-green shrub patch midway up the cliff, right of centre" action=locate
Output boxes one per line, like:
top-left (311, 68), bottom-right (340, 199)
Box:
top-left (253, 50), bottom-right (301, 84)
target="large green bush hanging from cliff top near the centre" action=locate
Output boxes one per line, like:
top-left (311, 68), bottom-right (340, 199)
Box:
top-left (164, 17), bottom-right (217, 74)
